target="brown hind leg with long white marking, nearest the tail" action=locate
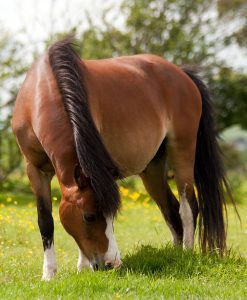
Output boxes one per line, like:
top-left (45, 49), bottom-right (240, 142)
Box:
top-left (168, 138), bottom-right (198, 249)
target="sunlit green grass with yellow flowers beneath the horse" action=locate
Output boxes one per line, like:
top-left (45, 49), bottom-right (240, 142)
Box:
top-left (0, 185), bottom-right (247, 299)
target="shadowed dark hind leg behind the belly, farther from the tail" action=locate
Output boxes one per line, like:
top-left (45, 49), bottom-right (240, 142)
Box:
top-left (140, 148), bottom-right (183, 246)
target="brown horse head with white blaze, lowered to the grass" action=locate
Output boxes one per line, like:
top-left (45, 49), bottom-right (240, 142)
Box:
top-left (59, 165), bottom-right (121, 270)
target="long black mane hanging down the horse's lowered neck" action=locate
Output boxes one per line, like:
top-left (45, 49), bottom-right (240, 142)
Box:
top-left (48, 37), bottom-right (120, 215)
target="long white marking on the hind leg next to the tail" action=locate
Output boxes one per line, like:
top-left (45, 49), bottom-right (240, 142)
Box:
top-left (179, 191), bottom-right (194, 249)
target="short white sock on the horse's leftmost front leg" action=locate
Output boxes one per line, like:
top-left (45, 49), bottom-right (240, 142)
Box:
top-left (42, 244), bottom-right (57, 281)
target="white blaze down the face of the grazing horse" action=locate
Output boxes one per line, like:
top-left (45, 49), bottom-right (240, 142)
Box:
top-left (104, 217), bottom-right (122, 268)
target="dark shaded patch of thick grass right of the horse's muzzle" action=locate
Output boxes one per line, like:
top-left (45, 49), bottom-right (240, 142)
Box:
top-left (120, 244), bottom-right (247, 279)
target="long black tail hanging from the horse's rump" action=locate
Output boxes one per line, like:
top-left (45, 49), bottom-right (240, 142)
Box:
top-left (183, 67), bottom-right (234, 253)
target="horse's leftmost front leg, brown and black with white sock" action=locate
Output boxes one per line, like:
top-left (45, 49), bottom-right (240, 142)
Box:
top-left (27, 162), bottom-right (57, 281)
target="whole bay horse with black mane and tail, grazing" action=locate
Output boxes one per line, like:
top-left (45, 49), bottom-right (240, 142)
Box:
top-left (12, 38), bottom-right (232, 280)
